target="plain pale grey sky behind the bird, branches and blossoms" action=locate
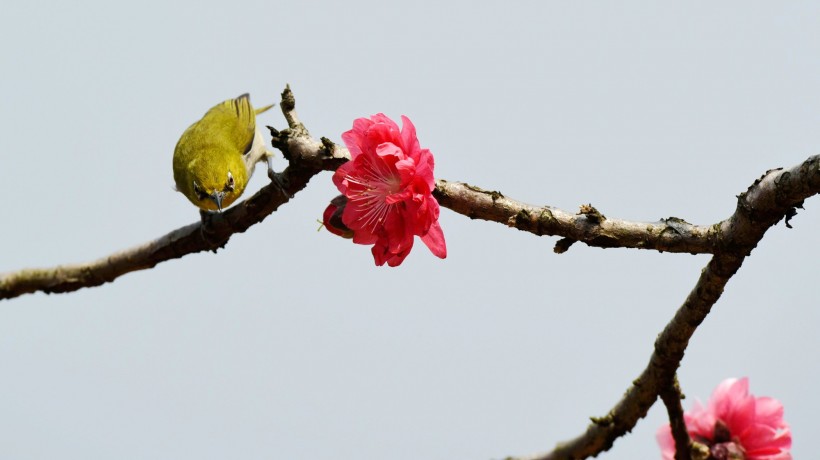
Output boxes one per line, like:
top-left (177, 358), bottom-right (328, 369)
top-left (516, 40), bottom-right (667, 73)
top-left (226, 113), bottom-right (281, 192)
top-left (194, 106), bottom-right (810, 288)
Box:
top-left (0, 1), bottom-right (820, 460)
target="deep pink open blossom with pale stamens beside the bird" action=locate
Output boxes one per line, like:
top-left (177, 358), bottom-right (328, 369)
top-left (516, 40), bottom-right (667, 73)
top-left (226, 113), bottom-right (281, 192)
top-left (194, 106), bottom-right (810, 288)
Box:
top-left (326, 113), bottom-right (447, 267)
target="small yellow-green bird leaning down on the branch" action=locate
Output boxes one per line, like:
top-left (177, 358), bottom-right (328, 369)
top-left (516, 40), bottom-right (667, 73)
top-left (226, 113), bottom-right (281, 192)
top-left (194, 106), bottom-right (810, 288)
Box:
top-left (174, 94), bottom-right (273, 211)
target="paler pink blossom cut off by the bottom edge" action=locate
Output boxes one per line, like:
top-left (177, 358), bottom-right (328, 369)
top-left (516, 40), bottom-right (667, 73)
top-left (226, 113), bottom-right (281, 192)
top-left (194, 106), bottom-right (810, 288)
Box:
top-left (656, 377), bottom-right (792, 460)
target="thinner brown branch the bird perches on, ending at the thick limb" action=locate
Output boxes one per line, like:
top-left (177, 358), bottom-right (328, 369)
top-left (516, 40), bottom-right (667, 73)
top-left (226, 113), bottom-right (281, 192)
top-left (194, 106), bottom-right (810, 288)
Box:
top-left (8, 88), bottom-right (800, 299)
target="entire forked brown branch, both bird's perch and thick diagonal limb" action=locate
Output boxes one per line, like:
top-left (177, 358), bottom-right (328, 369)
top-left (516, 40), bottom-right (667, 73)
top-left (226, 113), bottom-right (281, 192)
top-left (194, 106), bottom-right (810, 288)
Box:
top-left (0, 88), bottom-right (820, 460)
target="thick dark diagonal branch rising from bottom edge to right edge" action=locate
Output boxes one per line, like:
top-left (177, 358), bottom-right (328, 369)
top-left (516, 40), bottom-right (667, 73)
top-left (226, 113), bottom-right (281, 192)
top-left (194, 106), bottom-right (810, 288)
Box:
top-left (510, 156), bottom-right (820, 460)
